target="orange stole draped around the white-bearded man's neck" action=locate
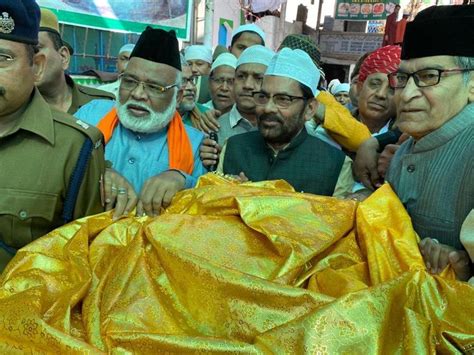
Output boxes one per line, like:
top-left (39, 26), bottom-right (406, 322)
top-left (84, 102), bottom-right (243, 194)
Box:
top-left (97, 107), bottom-right (194, 174)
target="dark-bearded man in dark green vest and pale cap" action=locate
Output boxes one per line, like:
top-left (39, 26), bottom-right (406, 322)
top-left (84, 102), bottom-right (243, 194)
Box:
top-left (218, 48), bottom-right (354, 197)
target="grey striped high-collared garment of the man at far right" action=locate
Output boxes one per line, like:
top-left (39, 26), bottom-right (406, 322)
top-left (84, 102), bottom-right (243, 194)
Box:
top-left (387, 103), bottom-right (474, 249)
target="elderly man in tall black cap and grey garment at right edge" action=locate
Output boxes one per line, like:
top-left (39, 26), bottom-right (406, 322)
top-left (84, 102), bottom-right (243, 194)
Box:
top-left (386, 5), bottom-right (474, 280)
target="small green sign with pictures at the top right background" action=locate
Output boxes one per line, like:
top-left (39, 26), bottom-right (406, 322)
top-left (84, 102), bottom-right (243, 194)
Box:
top-left (335, 0), bottom-right (399, 21)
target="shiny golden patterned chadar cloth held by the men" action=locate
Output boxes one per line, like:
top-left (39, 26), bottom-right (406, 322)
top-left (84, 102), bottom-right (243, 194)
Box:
top-left (0, 174), bottom-right (474, 355)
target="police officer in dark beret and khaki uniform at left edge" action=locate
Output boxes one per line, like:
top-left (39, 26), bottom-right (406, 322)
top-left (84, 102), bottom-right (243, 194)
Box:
top-left (0, 0), bottom-right (105, 270)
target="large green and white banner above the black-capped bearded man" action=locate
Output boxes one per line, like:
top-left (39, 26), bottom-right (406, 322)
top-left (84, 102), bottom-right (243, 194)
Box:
top-left (37, 0), bottom-right (193, 40)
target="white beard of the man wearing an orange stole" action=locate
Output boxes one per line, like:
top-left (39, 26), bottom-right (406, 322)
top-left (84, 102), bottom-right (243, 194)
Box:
top-left (116, 93), bottom-right (177, 133)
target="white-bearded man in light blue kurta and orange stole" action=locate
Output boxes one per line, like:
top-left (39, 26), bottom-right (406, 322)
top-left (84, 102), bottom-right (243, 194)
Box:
top-left (75, 27), bottom-right (205, 218)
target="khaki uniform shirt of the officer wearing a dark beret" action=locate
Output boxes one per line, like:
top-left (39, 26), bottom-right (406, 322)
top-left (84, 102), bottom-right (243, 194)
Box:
top-left (0, 89), bottom-right (105, 270)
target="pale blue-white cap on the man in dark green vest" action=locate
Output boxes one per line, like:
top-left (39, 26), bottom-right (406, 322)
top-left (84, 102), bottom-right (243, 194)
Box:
top-left (265, 48), bottom-right (320, 97)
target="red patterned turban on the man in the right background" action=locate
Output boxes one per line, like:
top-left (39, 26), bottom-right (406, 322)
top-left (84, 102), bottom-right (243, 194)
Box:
top-left (359, 46), bottom-right (402, 83)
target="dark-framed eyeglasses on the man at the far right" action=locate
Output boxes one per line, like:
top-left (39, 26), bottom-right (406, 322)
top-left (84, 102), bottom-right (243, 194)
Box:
top-left (388, 68), bottom-right (474, 89)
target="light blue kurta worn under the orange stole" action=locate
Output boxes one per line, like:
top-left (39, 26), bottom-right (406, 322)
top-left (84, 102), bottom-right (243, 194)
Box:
top-left (75, 100), bottom-right (206, 193)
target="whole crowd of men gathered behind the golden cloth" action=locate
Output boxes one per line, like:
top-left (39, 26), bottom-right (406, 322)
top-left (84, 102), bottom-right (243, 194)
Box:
top-left (0, 0), bottom-right (474, 286)
